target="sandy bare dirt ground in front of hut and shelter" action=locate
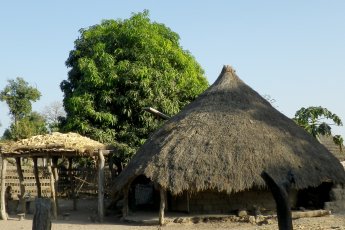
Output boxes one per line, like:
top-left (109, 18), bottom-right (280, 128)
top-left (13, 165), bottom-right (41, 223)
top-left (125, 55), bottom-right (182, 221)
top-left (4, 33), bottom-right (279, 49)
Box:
top-left (0, 201), bottom-right (345, 230)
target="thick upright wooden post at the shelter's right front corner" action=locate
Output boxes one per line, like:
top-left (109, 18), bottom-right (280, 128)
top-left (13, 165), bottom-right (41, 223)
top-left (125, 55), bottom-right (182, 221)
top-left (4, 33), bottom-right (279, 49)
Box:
top-left (98, 150), bottom-right (105, 222)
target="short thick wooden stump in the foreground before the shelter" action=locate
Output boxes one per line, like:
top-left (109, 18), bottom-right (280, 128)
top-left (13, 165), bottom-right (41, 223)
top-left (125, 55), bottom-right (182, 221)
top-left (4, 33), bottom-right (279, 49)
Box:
top-left (32, 198), bottom-right (52, 230)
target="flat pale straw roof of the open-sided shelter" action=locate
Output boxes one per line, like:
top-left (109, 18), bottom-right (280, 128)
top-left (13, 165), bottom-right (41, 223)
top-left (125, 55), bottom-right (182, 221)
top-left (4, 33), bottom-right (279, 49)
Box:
top-left (1, 132), bottom-right (107, 157)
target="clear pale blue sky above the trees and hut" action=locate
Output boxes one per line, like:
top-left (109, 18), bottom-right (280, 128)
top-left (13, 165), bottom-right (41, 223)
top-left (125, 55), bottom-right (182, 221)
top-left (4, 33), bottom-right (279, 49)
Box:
top-left (0, 0), bottom-right (345, 137)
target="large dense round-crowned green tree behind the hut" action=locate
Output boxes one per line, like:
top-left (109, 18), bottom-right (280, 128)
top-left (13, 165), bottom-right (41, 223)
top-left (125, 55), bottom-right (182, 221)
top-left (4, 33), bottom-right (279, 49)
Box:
top-left (61, 11), bottom-right (208, 162)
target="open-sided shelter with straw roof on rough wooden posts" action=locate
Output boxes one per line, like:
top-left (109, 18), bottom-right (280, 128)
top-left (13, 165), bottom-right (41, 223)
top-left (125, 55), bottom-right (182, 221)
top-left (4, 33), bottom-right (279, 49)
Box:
top-left (0, 132), bottom-right (111, 220)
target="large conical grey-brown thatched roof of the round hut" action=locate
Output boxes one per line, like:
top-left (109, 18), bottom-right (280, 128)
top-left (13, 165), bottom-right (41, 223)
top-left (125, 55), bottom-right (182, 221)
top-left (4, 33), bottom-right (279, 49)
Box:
top-left (115, 66), bottom-right (345, 194)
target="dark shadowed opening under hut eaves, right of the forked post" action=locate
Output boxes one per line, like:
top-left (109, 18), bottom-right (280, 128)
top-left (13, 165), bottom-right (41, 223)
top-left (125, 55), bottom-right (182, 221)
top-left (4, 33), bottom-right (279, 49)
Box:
top-left (297, 182), bottom-right (333, 209)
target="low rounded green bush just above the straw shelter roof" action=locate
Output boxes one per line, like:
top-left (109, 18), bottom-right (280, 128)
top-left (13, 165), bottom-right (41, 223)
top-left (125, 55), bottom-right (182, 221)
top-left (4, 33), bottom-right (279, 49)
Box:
top-left (3, 112), bottom-right (48, 140)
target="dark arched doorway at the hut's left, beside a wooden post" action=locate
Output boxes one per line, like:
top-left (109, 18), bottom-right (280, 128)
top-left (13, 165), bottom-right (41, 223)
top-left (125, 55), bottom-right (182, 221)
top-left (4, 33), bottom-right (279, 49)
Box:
top-left (128, 175), bottom-right (160, 211)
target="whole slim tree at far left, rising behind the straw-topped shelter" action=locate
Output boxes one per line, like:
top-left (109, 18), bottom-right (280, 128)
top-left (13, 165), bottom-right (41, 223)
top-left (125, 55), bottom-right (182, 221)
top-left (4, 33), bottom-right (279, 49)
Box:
top-left (0, 77), bottom-right (41, 140)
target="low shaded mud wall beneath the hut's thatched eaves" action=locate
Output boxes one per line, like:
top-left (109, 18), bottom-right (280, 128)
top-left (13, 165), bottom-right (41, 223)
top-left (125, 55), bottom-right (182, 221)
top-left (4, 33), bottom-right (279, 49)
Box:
top-left (170, 190), bottom-right (297, 214)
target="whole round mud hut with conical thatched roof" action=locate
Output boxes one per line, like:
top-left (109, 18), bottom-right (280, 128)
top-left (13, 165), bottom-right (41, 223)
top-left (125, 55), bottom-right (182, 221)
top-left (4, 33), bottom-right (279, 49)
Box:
top-left (114, 66), bottom-right (345, 223)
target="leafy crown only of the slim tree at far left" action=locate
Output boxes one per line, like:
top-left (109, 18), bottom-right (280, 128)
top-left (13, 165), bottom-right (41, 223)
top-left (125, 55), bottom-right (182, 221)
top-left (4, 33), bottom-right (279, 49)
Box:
top-left (0, 77), bottom-right (41, 122)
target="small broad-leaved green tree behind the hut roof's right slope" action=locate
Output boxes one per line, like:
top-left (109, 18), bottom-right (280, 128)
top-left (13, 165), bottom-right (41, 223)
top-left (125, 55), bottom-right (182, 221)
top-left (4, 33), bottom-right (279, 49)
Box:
top-left (293, 106), bottom-right (343, 151)
